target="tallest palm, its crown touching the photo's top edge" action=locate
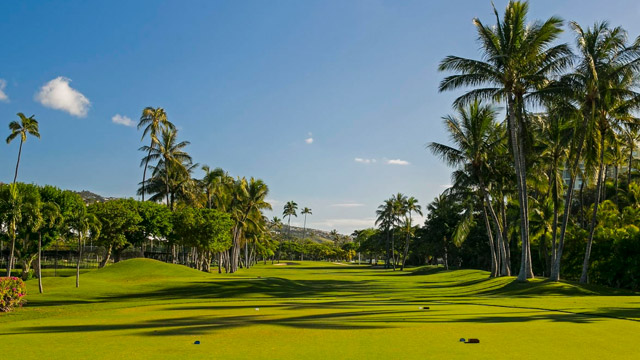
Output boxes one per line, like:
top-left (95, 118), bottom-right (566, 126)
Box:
top-left (439, 1), bottom-right (571, 281)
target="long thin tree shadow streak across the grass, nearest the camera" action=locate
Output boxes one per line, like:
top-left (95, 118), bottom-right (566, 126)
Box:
top-left (13, 305), bottom-right (632, 336)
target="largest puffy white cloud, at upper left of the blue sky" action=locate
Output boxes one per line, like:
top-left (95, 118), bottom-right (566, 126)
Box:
top-left (35, 76), bottom-right (91, 117)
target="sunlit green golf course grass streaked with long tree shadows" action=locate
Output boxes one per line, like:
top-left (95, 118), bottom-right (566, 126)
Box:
top-left (0, 259), bottom-right (640, 359)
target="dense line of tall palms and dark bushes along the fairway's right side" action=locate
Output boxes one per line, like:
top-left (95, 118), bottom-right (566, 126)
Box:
top-left (350, 1), bottom-right (640, 289)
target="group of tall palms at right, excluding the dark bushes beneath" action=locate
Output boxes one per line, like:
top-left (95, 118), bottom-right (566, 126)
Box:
top-left (436, 1), bottom-right (640, 283)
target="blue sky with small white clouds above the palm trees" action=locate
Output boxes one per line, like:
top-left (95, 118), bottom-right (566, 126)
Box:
top-left (0, 0), bottom-right (640, 234)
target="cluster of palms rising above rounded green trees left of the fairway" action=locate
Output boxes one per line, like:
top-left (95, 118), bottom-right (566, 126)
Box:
top-left (138, 107), bottom-right (274, 272)
